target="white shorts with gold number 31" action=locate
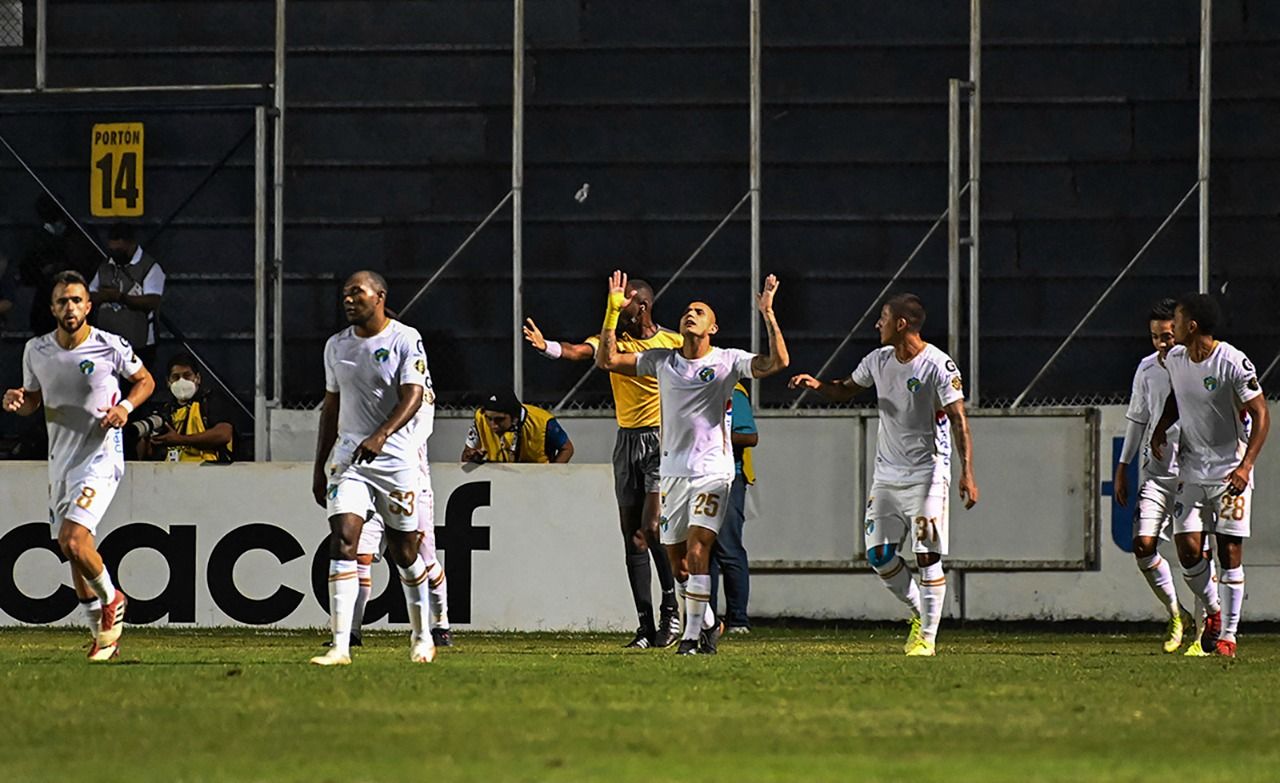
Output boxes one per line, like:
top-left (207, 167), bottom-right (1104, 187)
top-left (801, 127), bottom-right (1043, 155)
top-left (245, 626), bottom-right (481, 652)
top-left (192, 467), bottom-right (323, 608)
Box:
top-left (863, 471), bottom-right (951, 555)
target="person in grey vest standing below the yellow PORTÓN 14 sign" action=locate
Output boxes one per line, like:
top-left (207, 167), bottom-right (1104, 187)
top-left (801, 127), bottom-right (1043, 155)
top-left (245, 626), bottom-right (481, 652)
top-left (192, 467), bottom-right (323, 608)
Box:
top-left (88, 223), bottom-right (164, 368)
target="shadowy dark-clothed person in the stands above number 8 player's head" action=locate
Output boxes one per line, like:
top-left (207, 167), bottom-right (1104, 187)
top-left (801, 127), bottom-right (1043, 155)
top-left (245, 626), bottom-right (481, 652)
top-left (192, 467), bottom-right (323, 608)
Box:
top-left (18, 193), bottom-right (101, 335)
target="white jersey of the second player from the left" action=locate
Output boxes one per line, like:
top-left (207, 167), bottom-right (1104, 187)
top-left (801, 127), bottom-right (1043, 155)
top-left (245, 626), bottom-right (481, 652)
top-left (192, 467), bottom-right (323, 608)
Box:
top-left (324, 320), bottom-right (435, 464)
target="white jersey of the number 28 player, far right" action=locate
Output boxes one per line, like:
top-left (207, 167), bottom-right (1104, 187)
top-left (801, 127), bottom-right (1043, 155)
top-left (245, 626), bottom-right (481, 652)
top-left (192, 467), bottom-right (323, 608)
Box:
top-left (1165, 342), bottom-right (1262, 484)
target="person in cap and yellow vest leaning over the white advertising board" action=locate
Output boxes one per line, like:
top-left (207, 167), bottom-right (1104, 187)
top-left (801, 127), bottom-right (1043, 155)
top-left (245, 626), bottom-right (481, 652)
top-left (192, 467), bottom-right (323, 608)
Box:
top-left (462, 392), bottom-right (573, 464)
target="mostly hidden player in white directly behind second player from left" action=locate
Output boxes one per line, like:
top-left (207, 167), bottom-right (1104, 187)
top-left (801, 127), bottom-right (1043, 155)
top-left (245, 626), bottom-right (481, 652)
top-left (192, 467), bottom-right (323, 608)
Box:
top-left (348, 404), bottom-right (453, 647)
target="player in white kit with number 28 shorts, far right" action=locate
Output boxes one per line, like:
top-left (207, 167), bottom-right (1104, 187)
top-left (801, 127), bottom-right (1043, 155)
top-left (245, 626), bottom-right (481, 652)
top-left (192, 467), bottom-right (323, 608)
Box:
top-left (1151, 293), bottom-right (1271, 658)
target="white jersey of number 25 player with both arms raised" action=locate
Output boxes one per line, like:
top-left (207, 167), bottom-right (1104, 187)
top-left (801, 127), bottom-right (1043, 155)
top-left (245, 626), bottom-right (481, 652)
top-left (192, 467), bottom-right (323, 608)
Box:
top-left (636, 348), bottom-right (755, 479)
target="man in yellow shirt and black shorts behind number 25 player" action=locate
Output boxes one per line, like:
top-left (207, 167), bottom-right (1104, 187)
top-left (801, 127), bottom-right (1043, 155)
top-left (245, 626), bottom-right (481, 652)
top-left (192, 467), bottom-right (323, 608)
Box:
top-left (524, 280), bottom-right (684, 649)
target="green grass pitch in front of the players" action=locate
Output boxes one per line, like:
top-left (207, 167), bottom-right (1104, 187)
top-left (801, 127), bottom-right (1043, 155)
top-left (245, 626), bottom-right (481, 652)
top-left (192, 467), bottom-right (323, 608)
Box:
top-left (0, 626), bottom-right (1280, 783)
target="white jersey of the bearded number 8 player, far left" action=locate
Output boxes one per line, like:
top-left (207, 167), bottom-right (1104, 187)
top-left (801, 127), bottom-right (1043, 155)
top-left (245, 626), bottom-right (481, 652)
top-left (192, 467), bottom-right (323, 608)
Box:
top-left (22, 326), bottom-right (142, 482)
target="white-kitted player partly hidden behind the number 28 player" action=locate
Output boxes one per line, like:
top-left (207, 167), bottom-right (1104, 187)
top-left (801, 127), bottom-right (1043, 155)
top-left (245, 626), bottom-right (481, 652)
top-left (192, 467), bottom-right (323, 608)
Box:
top-left (1115, 299), bottom-right (1213, 656)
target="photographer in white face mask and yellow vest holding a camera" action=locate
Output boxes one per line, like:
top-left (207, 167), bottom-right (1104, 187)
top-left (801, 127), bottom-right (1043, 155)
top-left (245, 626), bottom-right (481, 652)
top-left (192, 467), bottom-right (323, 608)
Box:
top-left (131, 353), bottom-right (233, 463)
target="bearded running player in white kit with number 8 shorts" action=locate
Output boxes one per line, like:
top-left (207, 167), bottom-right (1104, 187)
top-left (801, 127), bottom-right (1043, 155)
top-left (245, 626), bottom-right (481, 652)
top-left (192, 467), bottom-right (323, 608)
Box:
top-left (4, 271), bottom-right (155, 661)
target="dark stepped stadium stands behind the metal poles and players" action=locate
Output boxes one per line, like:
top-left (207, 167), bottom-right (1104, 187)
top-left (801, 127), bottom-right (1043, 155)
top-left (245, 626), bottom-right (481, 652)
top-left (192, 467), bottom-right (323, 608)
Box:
top-left (0, 0), bottom-right (1280, 404)
